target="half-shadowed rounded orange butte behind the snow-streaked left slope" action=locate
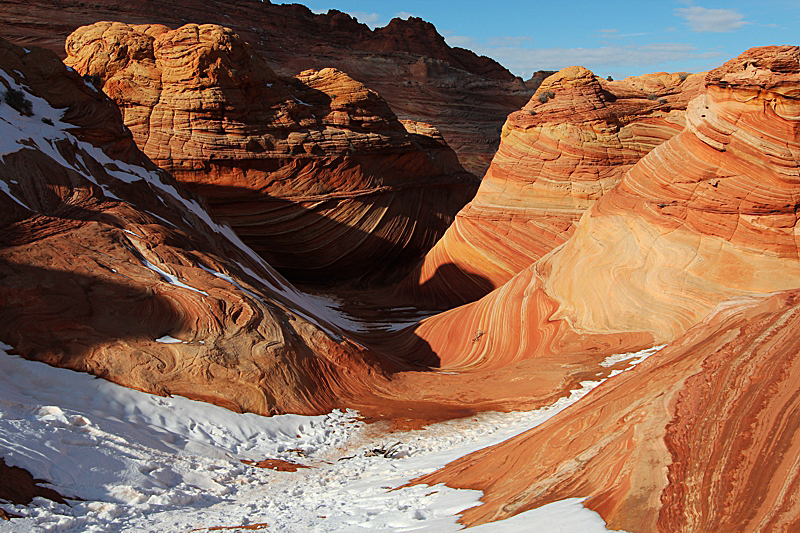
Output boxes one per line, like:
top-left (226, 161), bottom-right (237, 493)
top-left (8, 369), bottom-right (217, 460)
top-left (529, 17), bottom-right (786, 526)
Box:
top-left (66, 22), bottom-right (477, 284)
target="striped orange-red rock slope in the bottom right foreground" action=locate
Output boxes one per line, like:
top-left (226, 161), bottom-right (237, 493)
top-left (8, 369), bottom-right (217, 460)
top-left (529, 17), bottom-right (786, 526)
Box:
top-left (415, 291), bottom-right (800, 533)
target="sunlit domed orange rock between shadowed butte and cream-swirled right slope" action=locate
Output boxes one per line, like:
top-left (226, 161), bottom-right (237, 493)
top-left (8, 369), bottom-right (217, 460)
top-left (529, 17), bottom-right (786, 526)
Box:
top-left (397, 67), bottom-right (702, 308)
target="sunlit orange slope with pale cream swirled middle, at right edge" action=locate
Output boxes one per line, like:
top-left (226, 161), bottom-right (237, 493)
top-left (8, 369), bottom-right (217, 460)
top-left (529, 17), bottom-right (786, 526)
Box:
top-left (396, 47), bottom-right (800, 367)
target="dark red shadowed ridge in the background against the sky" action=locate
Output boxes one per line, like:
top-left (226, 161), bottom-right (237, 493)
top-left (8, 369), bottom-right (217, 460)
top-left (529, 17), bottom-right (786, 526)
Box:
top-left (0, 0), bottom-right (532, 176)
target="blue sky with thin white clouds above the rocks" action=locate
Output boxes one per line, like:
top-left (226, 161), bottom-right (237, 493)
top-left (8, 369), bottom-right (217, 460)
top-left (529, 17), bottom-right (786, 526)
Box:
top-left (286, 0), bottom-right (800, 79)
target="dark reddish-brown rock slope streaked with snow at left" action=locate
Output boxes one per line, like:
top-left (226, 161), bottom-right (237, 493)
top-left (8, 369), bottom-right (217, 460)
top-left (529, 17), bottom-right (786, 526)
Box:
top-left (0, 41), bottom-right (388, 414)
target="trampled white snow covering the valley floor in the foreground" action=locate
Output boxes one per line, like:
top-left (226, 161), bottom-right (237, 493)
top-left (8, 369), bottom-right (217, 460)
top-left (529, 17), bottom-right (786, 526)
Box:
top-left (0, 338), bottom-right (654, 533)
